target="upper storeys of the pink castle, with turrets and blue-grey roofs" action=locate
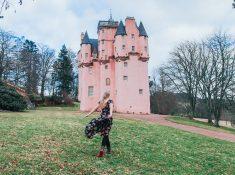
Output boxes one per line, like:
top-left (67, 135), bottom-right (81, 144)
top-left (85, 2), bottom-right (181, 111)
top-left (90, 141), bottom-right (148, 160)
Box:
top-left (78, 17), bottom-right (149, 67)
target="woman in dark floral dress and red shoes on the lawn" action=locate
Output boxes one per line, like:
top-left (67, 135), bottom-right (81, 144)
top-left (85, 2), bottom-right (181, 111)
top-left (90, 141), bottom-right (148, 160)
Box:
top-left (85, 92), bottom-right (113, 157)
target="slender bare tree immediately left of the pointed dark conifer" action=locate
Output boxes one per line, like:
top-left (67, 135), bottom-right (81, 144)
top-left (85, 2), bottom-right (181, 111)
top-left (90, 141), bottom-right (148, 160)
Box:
top-left (38, 44), bottom-right (55, 100)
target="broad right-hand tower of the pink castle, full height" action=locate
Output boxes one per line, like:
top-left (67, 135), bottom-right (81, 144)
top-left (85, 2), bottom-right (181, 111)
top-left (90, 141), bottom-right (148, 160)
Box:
top-left (114, 17), bottom-right (150, 114)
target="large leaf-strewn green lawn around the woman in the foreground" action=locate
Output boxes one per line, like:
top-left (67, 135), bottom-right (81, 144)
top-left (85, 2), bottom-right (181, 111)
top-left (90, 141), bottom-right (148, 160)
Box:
top-left (0, 107), bottom-right (235, 175)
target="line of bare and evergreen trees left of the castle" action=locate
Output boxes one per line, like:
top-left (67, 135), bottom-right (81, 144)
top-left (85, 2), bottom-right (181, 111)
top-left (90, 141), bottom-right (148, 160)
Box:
top-left (0, 28), bottom-right (78, 105)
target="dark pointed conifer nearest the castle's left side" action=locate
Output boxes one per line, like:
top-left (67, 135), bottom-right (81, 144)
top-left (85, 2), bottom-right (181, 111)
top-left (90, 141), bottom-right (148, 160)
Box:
top-left (56, 45), bottom-right (73, 99)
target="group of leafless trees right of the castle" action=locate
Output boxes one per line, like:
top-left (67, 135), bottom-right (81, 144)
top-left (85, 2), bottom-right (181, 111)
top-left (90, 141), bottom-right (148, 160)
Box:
top-left (151, 32), bottom-right (235, 126)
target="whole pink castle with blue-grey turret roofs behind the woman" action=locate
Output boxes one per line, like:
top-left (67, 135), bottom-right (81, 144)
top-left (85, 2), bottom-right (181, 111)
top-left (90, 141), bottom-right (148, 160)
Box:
top-left (78, 16), bottom-right (150, 114)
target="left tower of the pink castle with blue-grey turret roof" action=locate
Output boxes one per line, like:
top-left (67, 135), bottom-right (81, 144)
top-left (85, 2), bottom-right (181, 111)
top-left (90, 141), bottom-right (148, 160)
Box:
top-left (78, 32), bottom-right (100, 110)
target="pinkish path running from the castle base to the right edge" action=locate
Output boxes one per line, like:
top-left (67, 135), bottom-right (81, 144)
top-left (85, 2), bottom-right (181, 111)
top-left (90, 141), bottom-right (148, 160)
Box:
top-left (115, 114), bottom-right (235, 142)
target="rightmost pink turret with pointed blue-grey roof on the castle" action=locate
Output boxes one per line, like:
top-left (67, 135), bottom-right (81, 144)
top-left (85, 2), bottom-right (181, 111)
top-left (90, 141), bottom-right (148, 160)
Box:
top-left (138, 22), bottom-right (149, 61)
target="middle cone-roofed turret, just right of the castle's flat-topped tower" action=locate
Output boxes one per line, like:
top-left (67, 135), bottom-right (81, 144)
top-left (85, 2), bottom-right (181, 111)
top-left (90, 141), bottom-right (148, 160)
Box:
top-left (114, 21), bottom-right (128, 59)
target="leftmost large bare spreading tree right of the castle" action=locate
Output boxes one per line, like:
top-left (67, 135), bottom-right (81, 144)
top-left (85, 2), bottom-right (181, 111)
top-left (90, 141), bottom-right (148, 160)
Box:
top-left (164, 41), bottom-right (201, 117)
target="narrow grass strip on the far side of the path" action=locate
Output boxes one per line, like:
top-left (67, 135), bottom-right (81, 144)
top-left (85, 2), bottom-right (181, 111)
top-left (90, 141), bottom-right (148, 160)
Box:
top-left (167, 117), bottom-right (235, 134)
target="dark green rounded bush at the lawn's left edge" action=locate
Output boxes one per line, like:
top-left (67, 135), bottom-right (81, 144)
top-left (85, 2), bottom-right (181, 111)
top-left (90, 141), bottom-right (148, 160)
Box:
top-left (0, 82), bottom-right (27, 111)
